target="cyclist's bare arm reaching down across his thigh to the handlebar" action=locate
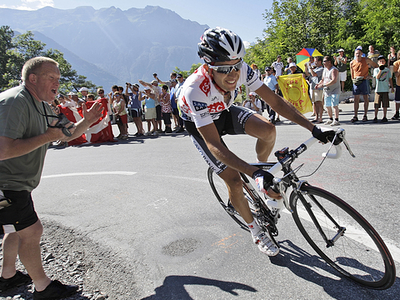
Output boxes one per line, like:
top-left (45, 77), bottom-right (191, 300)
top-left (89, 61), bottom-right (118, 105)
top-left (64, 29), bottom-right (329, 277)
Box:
top-left (197, 123), bottom-right (258, 176)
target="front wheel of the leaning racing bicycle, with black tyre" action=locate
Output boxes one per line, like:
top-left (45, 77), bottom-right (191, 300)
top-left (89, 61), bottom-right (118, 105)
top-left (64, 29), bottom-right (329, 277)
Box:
top-left (290, 185), bottom-right (396, 289)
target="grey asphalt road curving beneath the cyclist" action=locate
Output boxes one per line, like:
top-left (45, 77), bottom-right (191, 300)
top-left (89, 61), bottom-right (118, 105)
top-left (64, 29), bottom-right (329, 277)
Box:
top-left (33, 103), bottom-right (400, 299)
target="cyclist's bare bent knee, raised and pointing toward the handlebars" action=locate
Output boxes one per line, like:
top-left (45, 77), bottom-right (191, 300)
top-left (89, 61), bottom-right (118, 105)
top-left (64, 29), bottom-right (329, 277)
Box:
top-left (245, 114), bottom-right (276, 162)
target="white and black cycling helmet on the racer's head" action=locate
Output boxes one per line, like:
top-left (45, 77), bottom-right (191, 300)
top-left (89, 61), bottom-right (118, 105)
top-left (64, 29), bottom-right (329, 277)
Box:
top-left (198, 27), bottom-right (246, 64)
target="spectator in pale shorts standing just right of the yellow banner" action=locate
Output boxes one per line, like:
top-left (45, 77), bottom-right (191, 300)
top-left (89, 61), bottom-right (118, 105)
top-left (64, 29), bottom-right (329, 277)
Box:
top-left (309, 56), bottom-right (324, 124)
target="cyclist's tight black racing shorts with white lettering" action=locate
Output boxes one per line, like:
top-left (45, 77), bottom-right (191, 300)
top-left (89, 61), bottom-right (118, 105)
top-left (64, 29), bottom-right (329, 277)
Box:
top-left (185, 105), bottom-right (255, 174)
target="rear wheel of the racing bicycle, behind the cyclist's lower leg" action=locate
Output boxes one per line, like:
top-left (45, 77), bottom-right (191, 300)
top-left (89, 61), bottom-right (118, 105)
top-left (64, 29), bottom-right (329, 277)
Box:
top-left (207, 168), bottom-right (253, 231)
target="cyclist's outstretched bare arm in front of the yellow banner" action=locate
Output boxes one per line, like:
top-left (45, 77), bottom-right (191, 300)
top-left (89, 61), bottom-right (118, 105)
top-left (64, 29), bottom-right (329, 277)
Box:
top-left (255, 84), bottom-right (314, 132)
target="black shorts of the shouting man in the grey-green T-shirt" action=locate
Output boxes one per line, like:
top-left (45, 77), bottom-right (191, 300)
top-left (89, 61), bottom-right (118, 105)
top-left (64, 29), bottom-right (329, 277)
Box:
top-left (0, 190), bottom-right (38, 234)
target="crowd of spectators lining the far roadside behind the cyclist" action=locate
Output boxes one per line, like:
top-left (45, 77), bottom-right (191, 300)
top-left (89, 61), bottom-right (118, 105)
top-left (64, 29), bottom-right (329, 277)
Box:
top-left (53, 45), bottom-right (400, 145)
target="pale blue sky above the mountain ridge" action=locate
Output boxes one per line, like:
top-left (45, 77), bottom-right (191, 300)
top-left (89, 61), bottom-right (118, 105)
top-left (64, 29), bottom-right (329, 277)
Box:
top-left (0, 0), bottom-right (273, 43)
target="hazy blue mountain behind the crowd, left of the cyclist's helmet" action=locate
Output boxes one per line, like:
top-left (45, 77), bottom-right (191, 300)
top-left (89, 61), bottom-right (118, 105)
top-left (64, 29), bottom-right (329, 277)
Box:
top-left (0, 6), bottom-right (208, 89)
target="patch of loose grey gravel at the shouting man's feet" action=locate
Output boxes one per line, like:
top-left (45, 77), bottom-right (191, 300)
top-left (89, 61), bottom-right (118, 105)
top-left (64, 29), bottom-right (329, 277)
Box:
top-left (0, 220), bottom-right (139, 300)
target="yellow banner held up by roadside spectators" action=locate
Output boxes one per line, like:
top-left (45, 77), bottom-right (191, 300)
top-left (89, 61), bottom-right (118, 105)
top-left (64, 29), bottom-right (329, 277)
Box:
top-left (278, 74), bottom-right (313, 114)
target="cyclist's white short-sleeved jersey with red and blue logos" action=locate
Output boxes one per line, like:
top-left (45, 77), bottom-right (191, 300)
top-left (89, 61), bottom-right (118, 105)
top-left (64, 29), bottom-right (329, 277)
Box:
top-left (178, 63), bottom-right (263, 128)
